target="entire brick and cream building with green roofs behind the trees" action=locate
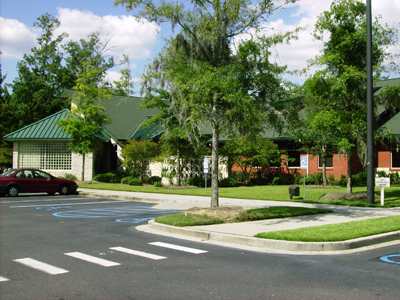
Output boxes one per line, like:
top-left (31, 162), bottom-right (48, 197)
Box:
top-left (4, 78), bottom-right (400, 180)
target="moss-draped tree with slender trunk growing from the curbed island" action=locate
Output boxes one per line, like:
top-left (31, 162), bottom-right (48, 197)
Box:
top-left (115, 0), bottom-right (296, 207)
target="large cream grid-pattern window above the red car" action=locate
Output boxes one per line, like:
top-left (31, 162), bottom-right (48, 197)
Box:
top-left (18, 142), bottom-right (71, 170)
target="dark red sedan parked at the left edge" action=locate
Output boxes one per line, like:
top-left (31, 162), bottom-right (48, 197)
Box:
top-left (0, 169), bottom-right (78, 197)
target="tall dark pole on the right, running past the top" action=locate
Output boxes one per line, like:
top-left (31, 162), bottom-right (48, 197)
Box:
top-left (367, 0), bottom-right (375, 203)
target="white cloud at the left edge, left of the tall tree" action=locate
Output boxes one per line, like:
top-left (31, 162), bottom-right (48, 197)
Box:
top-left (0, 17), bottom-right (37, 59)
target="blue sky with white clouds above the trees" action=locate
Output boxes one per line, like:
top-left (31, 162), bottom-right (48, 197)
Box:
top-left (0, 0), bottom-right (400, 91)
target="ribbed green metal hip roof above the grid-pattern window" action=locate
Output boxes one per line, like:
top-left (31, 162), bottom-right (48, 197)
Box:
top-left (3, 108), bottom-right (110, 141)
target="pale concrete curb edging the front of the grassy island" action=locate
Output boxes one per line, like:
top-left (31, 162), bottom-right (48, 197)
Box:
top-left (148, 220), bottom-right (400, 252)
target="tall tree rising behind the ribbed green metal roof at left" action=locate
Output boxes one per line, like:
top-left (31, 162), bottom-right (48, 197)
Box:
top-left (12, 14), bottom-right (74, 127)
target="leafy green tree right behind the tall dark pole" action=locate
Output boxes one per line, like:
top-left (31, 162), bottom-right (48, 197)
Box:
top-left (306, 0), bottom-right (397, 193)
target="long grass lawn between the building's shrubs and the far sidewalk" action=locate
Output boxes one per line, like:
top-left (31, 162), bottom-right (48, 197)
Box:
top-left (79, 183), bottom-right (400, 207)
